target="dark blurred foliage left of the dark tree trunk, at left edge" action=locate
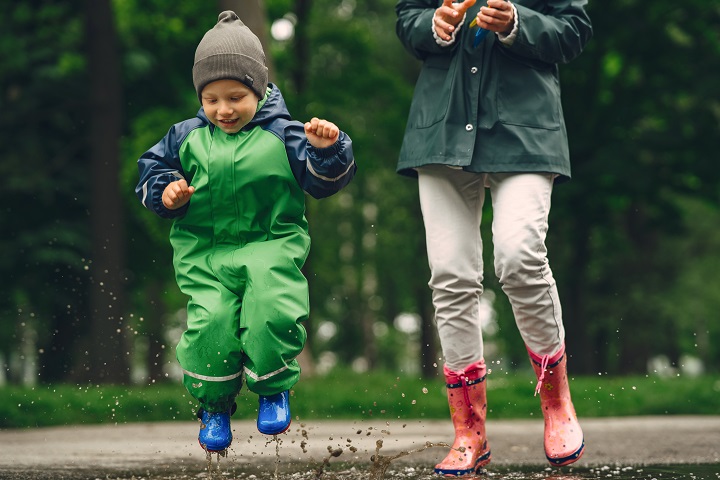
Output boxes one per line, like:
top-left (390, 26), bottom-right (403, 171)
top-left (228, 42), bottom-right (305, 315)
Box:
top-left (0, 1), bottom-right (90, 382)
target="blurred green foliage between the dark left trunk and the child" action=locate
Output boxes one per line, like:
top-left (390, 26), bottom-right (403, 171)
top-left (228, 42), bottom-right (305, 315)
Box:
top-left (114, 0), bottom-right (219, 382)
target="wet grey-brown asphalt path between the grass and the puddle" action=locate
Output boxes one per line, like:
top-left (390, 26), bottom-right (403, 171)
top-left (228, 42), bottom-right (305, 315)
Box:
top-left (0, 416), bottom-right (720, 479)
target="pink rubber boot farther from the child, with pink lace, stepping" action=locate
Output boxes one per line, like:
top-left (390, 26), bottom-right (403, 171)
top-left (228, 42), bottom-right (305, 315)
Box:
top-left (527, 345), bottom-right (585, 467)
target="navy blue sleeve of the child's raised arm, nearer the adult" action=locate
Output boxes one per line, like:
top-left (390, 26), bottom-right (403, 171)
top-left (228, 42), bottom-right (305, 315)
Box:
top-left (284, 121), bottom-right (357, 199)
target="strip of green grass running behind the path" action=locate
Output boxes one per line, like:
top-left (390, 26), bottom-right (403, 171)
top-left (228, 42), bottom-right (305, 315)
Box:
top-left (0, 371), bottom-right (720, 428)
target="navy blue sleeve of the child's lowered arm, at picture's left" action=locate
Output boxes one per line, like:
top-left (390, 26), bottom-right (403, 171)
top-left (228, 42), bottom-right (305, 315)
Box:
top-left (135, 119), bottom-right (201, 218)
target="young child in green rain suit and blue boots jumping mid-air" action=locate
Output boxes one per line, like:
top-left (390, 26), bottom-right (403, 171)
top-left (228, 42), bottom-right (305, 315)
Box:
top-left (135, 11), bottom-right (356, 452)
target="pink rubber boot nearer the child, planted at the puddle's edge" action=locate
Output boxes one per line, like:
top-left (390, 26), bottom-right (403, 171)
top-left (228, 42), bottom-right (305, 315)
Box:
top-left (435, 360), bottom-right (490, 477)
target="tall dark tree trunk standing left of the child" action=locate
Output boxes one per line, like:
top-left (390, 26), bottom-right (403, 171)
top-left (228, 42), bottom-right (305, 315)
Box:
top-left (80, 0), bottom-right (130, 383)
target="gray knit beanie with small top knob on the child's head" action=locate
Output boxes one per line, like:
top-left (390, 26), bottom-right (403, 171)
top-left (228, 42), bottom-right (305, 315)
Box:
top-left (193, 10), bottom-right (268, 102)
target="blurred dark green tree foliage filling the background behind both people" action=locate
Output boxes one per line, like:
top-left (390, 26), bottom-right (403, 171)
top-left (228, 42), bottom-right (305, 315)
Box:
top-left (0, 0), bottom-right (720, 386)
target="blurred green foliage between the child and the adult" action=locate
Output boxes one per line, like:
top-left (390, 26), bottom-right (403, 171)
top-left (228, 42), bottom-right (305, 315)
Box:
top-left (269, 0), bottom-right (434, 374)
